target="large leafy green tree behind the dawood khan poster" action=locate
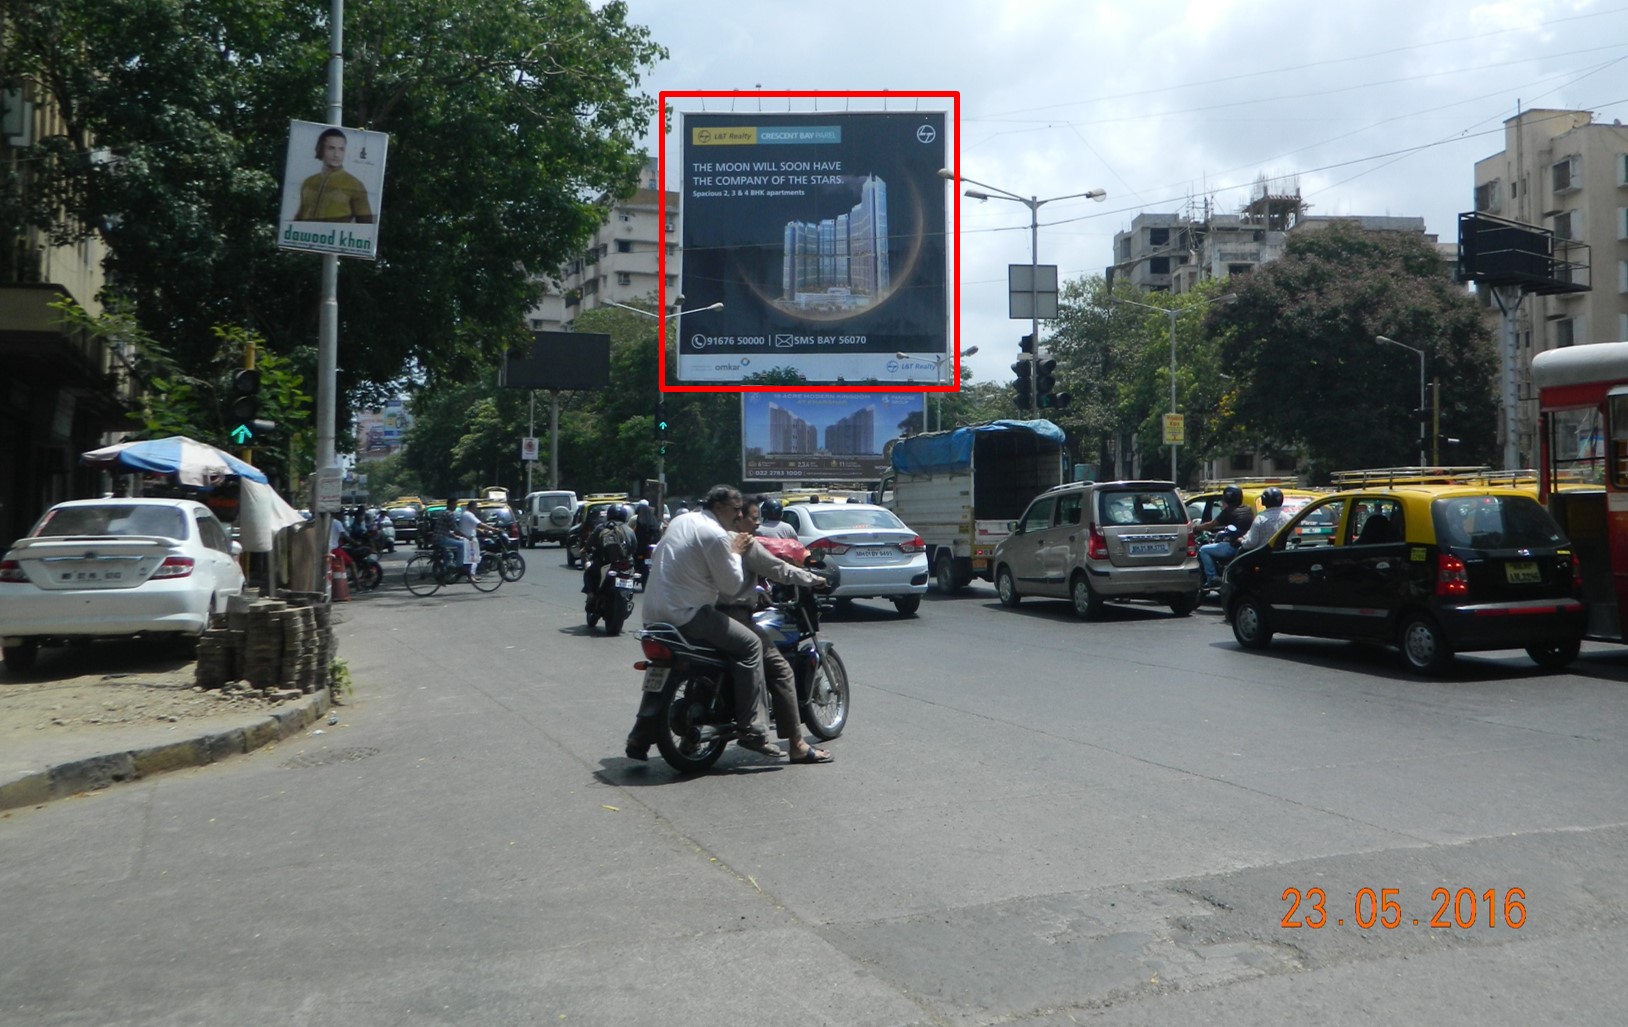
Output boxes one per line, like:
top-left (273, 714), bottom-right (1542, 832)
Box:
top-left (0, 0), bottom-right (666, 387)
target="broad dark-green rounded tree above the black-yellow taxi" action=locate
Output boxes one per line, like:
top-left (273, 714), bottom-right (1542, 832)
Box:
top-left (1213, 223), bottom-right (1498, 477)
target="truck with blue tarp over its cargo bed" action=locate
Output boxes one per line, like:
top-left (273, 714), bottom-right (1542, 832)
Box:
top-left (877, 420), bottom-right (1066, 594)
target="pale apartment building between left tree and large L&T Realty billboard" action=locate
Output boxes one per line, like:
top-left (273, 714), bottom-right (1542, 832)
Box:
top-left (526, 161), bottom-right (679, 332)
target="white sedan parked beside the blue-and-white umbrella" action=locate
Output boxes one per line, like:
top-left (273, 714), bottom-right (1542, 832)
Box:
top-left (0, 500), bottom-right (243, 672)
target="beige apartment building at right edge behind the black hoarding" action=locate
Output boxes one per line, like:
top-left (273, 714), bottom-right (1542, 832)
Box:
top-left (1473, 109), bottom-right (1628, 465)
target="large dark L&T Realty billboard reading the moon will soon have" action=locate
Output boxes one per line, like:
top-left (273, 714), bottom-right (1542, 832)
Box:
top-left (677, 111), bottom-right (952, 386)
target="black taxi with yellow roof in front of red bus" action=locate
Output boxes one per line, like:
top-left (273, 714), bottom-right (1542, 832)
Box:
top-left (1223, 482), bottom-right (1586, 674)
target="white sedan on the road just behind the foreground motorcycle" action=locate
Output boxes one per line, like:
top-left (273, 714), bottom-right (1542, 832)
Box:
top-left (781, 503), bottom-right (926, 617)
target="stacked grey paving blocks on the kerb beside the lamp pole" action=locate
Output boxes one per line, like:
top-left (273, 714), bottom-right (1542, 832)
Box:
top-left (195, 592), bottom-right (337, 697)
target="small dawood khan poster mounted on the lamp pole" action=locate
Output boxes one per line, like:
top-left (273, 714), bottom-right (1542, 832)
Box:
top-left (277, 120), bottom-right (391, 260)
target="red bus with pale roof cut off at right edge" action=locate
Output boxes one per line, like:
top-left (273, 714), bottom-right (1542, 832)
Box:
top-left (1532, 342), bottom-right (1628, 641)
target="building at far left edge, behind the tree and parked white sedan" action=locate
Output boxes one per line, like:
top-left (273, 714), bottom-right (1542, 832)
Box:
top-left (0, 83), bottom-right (138, 547)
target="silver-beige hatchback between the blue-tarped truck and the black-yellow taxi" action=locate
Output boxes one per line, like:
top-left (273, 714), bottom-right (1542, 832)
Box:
top-left (993, 482), bottom-right (1200, 618)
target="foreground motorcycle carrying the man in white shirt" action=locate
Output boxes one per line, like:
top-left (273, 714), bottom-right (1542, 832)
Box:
top-left (633, 568), bottom-right (848, 773)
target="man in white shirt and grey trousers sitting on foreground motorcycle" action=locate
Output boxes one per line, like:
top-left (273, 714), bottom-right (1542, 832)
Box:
top-left (625, 485), bottom-right (786, 760)
